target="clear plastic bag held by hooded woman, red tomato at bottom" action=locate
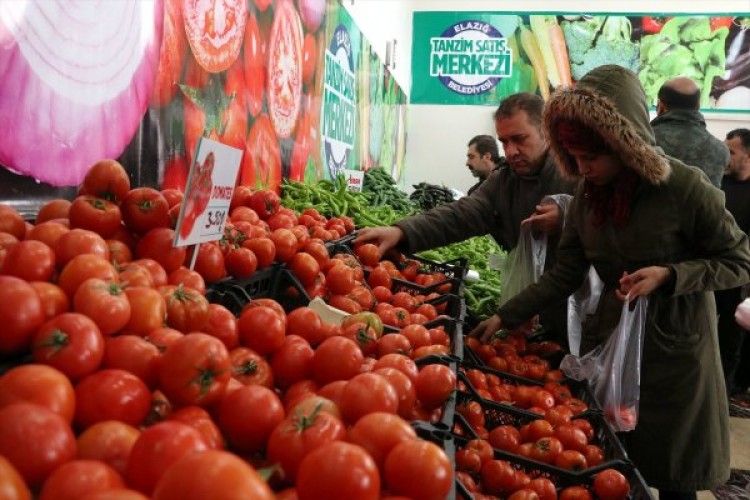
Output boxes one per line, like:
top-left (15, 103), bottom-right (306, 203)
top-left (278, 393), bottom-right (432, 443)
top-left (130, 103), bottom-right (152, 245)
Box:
top-left (560, 297), bottom-right (648, 432)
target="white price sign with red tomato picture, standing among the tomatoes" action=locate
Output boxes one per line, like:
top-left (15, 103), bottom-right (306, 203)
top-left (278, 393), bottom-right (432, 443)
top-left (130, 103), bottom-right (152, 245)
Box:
top-left (174, 137), bottom-right (243, 247)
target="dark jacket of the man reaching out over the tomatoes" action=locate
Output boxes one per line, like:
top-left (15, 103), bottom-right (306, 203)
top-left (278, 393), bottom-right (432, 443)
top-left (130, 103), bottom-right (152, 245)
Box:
top-left (396, 155), bottom-right (573, 252)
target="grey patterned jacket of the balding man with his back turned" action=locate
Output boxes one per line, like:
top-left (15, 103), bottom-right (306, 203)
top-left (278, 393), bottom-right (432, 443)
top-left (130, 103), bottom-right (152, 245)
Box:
top-left (651, 109), bottom-right (729, 187)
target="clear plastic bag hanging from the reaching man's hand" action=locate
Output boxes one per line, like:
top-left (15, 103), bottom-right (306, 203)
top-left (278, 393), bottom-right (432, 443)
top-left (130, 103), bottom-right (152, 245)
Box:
top-left (498, 226), bottom-right (547, 306)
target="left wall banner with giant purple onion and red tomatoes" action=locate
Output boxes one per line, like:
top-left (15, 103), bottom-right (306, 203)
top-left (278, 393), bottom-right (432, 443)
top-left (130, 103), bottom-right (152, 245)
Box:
top-left (0, 0), bottom-right (406, 200)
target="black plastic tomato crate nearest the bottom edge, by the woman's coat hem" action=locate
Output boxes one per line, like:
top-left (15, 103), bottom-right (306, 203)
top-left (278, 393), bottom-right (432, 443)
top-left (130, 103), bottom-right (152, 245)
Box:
top-left (450, 431), bottom-right (655, 500)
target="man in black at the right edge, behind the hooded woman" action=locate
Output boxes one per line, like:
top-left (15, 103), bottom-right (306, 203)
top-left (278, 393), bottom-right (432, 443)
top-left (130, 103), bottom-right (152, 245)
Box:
top-left (714, 128), bottom-right (750, 403)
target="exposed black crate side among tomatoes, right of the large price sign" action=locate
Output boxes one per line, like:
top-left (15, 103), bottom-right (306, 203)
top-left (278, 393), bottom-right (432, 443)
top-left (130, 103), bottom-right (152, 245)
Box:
top-left (206, 264), bottom-right (310, 315)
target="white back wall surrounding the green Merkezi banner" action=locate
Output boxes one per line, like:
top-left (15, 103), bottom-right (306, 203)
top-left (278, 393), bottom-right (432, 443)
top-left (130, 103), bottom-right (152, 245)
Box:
top-left (341, 0), bottom-right (750, 190)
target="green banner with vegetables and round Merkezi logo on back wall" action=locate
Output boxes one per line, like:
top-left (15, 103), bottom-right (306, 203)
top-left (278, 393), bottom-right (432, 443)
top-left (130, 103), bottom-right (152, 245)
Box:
top-left (411, 12), bottom-right (750, 112)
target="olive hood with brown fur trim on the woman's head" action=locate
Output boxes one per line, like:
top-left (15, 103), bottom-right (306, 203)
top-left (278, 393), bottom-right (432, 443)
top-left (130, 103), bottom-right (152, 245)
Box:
top-left (544, 65), bottom-right (670, 184)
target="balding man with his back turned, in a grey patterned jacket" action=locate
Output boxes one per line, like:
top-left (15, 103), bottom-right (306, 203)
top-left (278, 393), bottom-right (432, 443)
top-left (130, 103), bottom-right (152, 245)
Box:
top-left (651, 76), bottom-right (729, 187)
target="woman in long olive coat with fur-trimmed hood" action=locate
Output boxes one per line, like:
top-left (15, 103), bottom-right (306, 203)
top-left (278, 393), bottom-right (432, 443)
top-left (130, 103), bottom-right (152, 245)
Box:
top-left (472, 65), bottom-right (750, 500)
